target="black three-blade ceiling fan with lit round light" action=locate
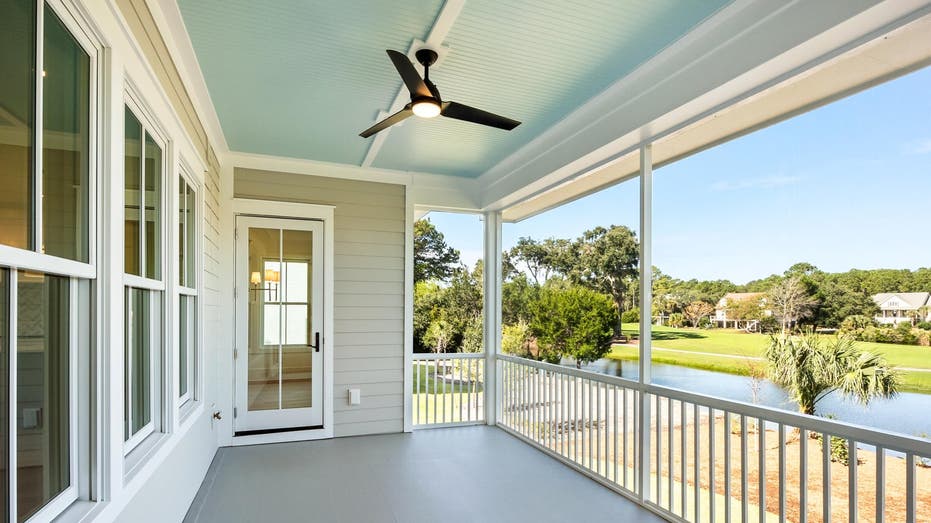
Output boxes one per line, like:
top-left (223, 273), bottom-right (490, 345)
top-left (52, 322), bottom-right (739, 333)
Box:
top-left (359, 49), bottom-right (520, 138)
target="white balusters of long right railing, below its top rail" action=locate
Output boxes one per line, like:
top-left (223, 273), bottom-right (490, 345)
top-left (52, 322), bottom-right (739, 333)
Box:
top-left (497, 355), bottom-right (931, 522)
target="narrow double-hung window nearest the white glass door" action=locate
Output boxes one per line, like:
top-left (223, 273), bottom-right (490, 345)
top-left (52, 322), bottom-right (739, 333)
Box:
top-left (177, 174), bottom-right (199, 406)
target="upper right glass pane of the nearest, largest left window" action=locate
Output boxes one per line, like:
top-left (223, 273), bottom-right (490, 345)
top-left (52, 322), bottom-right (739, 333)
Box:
top-left (42, 6), bottom-right (90, 262)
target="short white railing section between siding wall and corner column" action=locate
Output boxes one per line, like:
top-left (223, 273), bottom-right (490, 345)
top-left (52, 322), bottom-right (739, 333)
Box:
top-left (413, 353), bottom-right (485, 428)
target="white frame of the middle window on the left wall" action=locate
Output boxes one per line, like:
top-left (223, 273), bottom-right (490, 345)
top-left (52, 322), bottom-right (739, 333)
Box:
top-left (119, 95), bottom-right (174, 458)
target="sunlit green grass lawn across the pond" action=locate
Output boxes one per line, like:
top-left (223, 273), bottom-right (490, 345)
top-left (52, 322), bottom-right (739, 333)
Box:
top-left (607, 324), bottom-right (931, 393)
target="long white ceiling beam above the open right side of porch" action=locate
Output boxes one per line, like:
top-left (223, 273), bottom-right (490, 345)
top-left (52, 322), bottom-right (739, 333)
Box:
top-left (479, 0), bottom-right (931, 214)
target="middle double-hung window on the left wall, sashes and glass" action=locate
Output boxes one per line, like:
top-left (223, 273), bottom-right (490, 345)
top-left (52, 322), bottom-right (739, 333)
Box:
top-left (123, 103), bottom-right (165, 454)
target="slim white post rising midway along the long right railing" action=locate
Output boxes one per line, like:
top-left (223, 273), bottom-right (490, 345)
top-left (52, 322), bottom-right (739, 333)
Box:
top-left (638, 145), bottom-right (660, 501)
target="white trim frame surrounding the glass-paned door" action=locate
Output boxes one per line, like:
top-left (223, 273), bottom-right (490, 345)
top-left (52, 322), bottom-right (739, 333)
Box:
top-left (228, 198), bottom-right (334, 445)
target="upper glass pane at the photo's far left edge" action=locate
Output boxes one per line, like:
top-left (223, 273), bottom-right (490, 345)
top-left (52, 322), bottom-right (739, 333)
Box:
top-left (0, 0), bottom-right (36, 249)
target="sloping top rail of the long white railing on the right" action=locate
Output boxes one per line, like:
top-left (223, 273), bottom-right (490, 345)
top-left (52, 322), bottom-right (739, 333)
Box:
top-left (497, 354), bottom-right (931, 457)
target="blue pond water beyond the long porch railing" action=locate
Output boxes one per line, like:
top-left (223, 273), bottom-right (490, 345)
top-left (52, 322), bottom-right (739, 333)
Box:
top-left (563, 359), bottom-right (931, 437)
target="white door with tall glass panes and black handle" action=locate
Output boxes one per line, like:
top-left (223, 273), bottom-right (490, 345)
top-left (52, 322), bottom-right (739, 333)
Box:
top-left (235, 216), bottom-right (327, 435)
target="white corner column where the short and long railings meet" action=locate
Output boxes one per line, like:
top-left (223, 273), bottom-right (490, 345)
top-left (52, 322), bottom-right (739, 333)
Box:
top-left (483, 211), bottom-right (502, 425)
